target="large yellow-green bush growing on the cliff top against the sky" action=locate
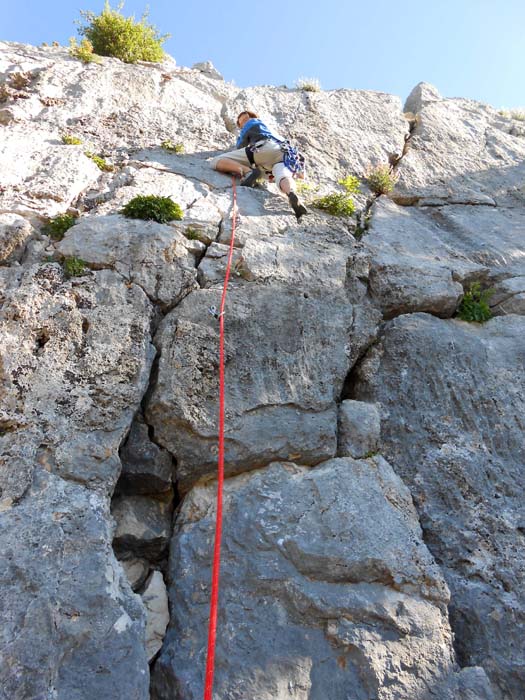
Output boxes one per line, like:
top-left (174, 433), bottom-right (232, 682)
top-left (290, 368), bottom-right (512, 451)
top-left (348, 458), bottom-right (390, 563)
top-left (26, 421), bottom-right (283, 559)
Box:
top-left (78, 0), bottom-right (169, 63)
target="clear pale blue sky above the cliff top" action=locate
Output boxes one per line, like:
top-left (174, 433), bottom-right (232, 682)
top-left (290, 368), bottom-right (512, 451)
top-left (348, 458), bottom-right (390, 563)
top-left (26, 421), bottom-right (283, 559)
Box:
top-left (0, 0), bottom-right (525, 108)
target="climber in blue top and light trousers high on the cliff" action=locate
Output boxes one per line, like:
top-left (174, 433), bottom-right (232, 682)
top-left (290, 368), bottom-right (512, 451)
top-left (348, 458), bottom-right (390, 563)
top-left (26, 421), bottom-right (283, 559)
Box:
top-left (211, 110), bottom-right (308, 221)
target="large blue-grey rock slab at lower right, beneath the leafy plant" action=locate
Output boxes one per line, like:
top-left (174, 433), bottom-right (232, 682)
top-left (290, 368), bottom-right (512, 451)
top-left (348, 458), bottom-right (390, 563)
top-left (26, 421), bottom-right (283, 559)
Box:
top-left (353, 314), bottom-right (525, 698)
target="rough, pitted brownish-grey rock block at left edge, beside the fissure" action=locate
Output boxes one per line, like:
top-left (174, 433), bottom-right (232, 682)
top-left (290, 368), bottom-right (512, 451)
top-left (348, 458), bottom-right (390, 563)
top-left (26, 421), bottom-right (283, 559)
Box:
top-left (0, 264), bottom-right (153, 505)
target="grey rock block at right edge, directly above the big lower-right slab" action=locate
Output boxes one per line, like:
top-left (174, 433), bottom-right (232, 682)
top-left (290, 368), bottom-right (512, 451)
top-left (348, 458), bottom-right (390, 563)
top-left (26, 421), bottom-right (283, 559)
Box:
top-left (364, 196), bottom-right (525, 318)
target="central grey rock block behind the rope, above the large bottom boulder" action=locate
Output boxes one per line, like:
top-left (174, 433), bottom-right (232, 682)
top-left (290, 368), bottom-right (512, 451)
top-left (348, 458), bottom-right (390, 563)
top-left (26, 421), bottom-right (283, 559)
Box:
top-left (146, 202), bottom-right (380, 491)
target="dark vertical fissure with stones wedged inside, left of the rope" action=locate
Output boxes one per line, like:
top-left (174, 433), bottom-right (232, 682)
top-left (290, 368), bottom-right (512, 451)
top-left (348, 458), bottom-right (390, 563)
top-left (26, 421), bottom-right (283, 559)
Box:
top-left (106, 285), bottom-right (191, 676)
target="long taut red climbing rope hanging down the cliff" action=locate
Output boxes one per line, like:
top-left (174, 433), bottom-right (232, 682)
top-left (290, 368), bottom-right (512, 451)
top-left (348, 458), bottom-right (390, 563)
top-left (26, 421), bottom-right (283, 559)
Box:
top-left (204, 177), bottom-right (237, 700)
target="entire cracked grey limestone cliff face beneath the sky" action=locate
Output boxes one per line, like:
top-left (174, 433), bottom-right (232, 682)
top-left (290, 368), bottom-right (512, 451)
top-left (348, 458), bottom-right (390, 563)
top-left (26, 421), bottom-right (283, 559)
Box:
top-left (0, 43), bottom-right (525, 700)
